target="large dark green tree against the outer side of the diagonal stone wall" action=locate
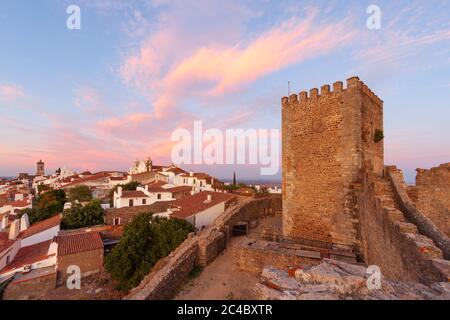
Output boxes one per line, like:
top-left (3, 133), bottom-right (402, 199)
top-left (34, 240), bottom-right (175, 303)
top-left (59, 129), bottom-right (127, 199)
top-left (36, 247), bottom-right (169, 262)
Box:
top-left (105, 213), bottom-right (194, 291)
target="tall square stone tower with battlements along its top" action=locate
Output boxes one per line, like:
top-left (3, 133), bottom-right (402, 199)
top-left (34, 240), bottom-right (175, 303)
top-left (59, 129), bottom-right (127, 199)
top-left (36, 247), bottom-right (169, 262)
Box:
top-left (282, 77), bottom-right (384, 245)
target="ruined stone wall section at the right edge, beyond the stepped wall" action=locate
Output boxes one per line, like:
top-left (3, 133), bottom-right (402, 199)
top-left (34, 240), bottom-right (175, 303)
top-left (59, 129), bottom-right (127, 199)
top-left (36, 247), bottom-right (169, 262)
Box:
top-left (409, 163), bottom-right (450, 237)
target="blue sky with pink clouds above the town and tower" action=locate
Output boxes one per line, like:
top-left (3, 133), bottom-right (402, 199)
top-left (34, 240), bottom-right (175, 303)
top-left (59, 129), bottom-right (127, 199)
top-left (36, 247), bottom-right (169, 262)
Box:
top-left (0, 0), bottom-right (450, 181)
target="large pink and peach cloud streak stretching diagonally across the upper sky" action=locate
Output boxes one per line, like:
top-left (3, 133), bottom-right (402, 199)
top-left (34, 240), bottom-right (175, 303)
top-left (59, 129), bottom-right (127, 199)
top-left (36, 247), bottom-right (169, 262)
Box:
top-left (120, 10), bottom-right (356, 118)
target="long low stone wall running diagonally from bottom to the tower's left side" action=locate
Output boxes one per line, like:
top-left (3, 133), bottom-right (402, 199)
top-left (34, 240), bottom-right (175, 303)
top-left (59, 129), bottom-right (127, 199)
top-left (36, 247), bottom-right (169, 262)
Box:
top-left (124, 196), bottom-right (281, 300)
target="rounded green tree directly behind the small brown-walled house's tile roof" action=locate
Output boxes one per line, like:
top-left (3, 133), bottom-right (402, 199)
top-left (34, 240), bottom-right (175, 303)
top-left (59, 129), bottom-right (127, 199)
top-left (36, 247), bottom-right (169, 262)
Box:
top-left (61, 200), bottom-right (104, 230)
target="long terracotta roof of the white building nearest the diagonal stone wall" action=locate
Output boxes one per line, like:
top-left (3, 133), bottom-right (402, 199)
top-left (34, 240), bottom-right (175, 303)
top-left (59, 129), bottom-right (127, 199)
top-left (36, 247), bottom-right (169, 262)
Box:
top-left (170, 191), bottom-right (236, 219)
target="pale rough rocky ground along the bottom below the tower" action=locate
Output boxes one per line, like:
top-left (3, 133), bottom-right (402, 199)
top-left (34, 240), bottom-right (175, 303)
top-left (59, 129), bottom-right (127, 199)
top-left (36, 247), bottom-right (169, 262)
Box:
top-left (254, 259), bottom-right (450, 300)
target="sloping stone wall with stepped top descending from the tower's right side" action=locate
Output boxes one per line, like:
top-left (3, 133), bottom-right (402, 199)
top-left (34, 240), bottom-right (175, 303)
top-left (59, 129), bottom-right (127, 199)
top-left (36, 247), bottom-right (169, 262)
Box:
top-left (358, 168), bottom-right (450, 284)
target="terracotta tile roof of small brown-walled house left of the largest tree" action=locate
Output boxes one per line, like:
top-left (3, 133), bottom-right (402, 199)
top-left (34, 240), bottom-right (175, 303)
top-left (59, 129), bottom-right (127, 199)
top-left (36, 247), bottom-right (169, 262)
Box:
top-left (54, 232), bottom-right (103, 256)
